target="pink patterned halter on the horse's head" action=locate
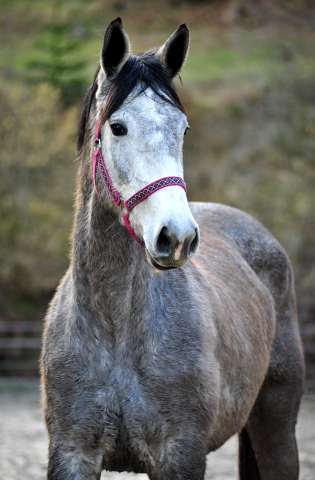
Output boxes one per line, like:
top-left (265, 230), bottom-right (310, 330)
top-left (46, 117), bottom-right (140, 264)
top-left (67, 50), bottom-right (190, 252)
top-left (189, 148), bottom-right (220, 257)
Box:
top-left (93, 120), bottom-right (186, 248)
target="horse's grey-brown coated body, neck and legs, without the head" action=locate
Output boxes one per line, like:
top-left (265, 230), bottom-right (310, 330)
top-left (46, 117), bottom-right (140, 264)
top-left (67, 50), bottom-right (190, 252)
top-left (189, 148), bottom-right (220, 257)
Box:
top-left (41, 19), bottom-right (304, 480)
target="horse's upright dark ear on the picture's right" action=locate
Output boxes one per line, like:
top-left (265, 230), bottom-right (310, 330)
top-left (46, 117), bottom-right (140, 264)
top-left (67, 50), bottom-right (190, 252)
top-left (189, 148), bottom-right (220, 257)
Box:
top-left (157, 23), bottom-right (189, 78)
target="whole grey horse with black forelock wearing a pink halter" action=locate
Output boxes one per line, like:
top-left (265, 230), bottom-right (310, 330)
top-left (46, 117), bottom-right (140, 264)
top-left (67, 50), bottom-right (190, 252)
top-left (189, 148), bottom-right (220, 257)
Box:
top-left (41, 18), bottom-right (304, 480)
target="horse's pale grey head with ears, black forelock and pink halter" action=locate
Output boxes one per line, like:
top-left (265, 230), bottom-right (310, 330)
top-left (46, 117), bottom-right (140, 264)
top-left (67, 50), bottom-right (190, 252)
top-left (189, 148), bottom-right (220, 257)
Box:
top-left (94, 18), bottom-right (199, 270)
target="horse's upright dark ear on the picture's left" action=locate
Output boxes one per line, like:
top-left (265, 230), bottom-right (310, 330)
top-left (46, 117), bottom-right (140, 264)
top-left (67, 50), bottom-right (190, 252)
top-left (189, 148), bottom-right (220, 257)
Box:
top-left (101, 17), bottom-right (130, 78)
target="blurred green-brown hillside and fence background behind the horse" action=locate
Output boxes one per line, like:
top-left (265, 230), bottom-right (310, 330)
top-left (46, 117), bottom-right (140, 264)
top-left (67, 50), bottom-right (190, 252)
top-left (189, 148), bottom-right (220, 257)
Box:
top-left (0, 0), bottom-right (315, 382)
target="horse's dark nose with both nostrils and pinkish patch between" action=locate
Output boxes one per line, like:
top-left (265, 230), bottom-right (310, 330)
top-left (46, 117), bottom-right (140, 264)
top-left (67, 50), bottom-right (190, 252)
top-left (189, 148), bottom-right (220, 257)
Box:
top-left (154, 226), bottom-right (199, 264)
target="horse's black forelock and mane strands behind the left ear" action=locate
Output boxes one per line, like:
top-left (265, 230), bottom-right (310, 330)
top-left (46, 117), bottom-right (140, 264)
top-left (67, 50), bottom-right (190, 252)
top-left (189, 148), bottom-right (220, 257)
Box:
top-left (77, 52), bottom-right (185, 151)
